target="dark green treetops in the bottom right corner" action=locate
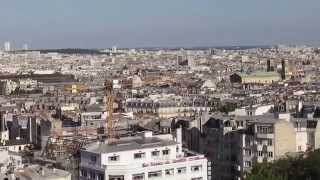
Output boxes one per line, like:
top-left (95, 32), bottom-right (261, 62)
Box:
top-left (246, 150), bottom-right (320, 180)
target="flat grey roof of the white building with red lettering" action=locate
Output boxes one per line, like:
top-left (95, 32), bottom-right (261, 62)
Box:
top-left (85, 137), bottom-right (177, 153)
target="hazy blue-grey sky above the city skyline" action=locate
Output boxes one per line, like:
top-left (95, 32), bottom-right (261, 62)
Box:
top-left (0, 0), bottom-right (320, 48)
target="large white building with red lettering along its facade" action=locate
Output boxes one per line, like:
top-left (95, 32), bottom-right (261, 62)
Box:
top-left (80, 129), bottom-right (210, 180)
